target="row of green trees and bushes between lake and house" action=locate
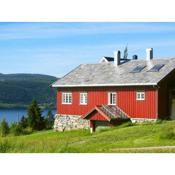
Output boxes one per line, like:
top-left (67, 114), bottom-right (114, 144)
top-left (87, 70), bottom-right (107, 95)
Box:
top-left (0, 100), bottom-right (54, 136)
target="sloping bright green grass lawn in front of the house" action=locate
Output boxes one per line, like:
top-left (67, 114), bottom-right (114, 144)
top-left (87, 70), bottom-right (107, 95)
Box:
top-left (0, 121), bottom-right (175, 153)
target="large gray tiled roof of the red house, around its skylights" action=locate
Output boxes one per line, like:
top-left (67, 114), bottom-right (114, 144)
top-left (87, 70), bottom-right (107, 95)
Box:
top-left (52, 58), bottom-right (175, 87)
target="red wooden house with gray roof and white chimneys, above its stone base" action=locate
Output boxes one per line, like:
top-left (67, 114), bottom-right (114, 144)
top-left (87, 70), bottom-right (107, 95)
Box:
top-left (52, 49), bottom-right (175, 132)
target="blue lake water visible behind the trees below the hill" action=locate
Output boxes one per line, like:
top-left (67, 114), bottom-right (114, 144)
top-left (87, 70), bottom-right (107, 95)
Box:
top-left (0, 109), bottom-right (56, 123)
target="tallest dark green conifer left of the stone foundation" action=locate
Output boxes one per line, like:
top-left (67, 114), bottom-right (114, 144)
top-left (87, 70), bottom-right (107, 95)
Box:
top-left (27, 100), bottom-right (44, 130)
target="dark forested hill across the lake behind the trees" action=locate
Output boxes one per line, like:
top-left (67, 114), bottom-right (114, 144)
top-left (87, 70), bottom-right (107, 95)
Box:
top-left (0, 74), bottom-right (57, 108)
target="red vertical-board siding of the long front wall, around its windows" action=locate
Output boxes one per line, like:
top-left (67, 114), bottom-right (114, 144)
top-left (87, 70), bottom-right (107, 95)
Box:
top-left (57, 87), bottom-right (157, 119)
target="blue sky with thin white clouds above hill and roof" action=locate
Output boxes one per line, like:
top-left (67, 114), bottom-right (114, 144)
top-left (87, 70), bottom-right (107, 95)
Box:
top-left (0, 22), bottom-right (175, 77)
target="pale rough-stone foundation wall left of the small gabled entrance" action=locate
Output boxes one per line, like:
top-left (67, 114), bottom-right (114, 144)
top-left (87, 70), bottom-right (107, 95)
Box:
top-left (54, 114), bottom-right (89, 131)
